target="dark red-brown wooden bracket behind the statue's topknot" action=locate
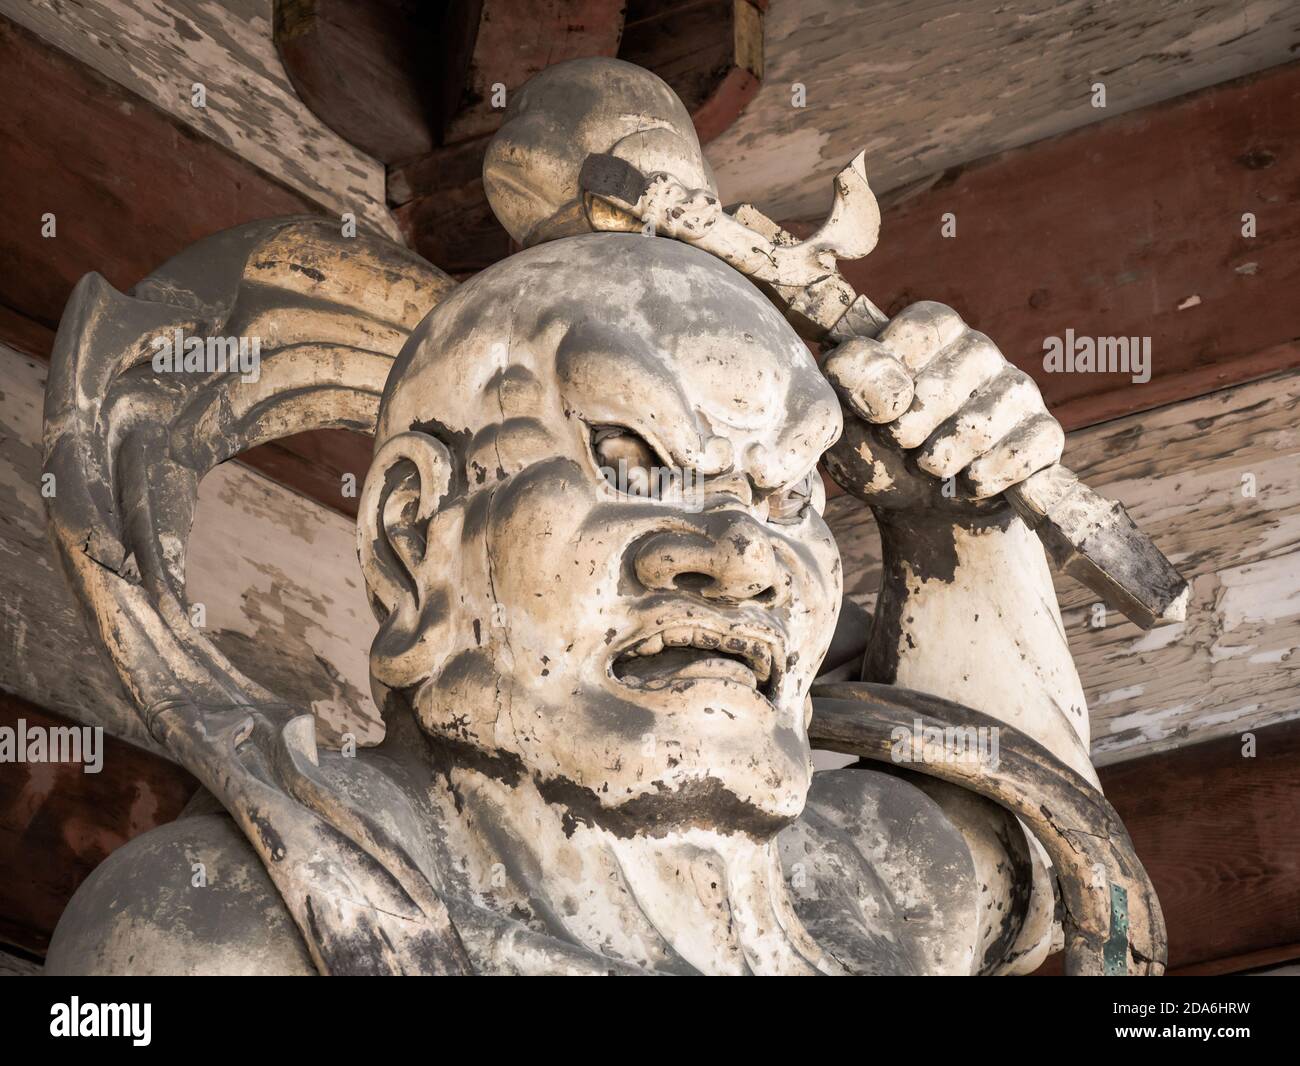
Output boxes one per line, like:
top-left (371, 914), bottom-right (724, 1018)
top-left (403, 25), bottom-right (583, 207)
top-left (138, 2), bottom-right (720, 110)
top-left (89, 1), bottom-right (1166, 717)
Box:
top-left (384, 0), bottom-right (763, 277)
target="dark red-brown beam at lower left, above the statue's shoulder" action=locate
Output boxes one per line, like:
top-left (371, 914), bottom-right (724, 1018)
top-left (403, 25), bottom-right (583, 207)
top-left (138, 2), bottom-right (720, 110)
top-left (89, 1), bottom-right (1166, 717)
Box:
top-left (0, 690), bottom-right (199, 956)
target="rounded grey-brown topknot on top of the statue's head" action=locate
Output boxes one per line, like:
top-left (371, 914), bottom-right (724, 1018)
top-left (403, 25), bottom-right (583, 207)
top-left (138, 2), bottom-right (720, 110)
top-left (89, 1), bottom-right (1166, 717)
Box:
top-left (484, 57), bottom-right (716, 247)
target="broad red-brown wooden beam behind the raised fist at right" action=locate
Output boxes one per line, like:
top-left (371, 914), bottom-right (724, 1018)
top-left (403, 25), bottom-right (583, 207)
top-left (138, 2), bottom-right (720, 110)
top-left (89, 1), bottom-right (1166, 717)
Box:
top-left (842, 64), bottom-right (1300, 428)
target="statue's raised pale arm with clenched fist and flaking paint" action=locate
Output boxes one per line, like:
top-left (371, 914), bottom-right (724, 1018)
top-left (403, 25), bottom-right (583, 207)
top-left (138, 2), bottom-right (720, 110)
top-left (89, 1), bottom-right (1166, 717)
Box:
top-left (824, 303), bottom-right (1096, 781)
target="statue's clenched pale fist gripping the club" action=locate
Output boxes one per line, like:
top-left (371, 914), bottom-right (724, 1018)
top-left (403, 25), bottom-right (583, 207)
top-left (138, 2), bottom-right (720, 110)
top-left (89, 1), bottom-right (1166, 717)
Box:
top-left (822, 302), bottom-right (1065, 510)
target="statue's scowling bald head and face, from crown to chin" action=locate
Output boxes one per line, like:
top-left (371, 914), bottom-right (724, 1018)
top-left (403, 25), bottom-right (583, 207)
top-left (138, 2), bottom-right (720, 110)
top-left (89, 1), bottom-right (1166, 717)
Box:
top-left (363, 234), bottom-right (841, 833)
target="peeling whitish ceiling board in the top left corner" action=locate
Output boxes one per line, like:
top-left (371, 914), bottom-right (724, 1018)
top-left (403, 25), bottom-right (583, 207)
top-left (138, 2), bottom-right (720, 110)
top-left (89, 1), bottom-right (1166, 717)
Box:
top-left (0, 0), bottom-right (400, 243)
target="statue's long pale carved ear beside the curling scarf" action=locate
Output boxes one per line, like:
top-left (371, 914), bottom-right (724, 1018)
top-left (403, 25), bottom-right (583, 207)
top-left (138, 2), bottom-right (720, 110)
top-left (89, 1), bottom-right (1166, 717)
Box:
top-left (356, 432), bottom-right (452, 619)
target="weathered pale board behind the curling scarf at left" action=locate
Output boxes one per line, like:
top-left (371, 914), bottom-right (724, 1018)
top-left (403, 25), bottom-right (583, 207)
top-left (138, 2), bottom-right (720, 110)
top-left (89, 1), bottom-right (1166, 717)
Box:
top-left (0, 346), bottom-right (382, 750)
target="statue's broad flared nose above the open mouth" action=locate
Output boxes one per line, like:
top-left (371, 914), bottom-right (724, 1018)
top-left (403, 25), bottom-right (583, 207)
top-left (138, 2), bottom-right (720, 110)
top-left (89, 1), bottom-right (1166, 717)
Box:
top-left (634, 508), bottom-right (788, 606)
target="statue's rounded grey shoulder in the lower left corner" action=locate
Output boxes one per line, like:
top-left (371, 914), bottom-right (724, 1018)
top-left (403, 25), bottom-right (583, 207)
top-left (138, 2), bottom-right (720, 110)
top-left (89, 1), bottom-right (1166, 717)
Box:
top-left (46, 811), bottom-right (316, 975)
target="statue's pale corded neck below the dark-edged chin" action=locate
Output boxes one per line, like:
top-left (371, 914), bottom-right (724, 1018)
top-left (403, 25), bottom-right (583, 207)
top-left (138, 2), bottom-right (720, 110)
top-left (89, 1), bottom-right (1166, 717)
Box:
top-left (441, 770), bottom-right (833, 974)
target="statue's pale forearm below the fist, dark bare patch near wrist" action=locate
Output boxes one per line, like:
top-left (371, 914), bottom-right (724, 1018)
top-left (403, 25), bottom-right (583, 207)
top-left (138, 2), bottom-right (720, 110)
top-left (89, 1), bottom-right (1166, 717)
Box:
top-left (865, 511), bottom-right (1096, 780)
